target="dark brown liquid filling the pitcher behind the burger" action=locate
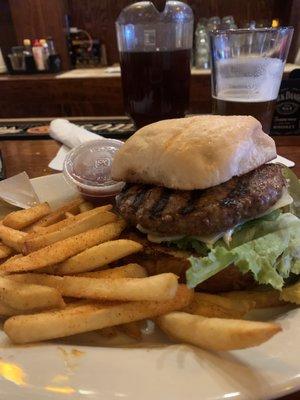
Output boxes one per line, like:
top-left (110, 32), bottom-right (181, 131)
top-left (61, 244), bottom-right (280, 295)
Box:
top-left (120, 50), bottom-right (191, 128)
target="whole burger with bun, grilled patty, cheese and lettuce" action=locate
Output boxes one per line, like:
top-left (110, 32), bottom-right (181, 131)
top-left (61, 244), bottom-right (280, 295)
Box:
top-left (112, 115), bottom-right (300, 292)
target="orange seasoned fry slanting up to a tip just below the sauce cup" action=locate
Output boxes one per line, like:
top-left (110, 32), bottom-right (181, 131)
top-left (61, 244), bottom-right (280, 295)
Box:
top-left (23, 210), bottom-right (117, 254)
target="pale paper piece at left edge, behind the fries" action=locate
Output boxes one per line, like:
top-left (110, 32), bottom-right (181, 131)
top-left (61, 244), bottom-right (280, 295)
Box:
top-left (0, 172), bottom-right (39, 208)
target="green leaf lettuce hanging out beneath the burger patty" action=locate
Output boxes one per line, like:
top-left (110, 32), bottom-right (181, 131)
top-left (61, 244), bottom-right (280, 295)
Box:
top-left (186, 168), bottom-right (300, 290)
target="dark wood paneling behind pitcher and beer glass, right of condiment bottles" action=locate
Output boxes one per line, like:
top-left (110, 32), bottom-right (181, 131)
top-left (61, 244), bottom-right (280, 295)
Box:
top-left (68, 0), bottom-right (300, 64)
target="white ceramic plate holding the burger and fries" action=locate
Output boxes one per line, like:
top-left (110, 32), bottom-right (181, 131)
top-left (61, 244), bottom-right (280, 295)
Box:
top-left (0, 174), bottom-right (300, 400)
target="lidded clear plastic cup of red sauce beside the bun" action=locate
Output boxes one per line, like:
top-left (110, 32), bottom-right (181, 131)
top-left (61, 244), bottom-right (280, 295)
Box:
top-left (63, 139), bottom-right (124, 197)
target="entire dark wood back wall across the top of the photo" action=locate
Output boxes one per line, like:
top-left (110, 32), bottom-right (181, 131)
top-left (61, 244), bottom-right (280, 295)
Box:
top-left (0, 0), bottom-right (300, 69)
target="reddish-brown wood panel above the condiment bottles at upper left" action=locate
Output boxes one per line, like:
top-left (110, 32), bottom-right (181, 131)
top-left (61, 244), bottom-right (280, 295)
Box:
top-left (9, 0), bottom-right (70, 69)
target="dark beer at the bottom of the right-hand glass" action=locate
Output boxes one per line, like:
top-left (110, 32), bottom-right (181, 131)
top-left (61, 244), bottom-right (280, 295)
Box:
top-left (212, 97), bottom-right (276, 133)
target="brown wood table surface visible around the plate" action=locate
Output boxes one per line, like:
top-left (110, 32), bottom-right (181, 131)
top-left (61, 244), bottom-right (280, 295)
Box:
top-left (0, 136), bottom-right (300, 400)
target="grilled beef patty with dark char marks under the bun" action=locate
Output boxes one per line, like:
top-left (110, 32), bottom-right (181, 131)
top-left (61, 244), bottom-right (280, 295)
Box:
top-left (116, 164), bottom-right (286, 236)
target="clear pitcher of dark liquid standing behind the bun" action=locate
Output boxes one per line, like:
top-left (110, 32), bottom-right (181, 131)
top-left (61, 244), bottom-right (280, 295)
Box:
top-left (116, 1), bottom-right (193, 128)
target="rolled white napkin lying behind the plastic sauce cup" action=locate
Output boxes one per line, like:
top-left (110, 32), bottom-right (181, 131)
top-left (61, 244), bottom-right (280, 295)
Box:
top-left (49, 118), bottom-right (103, 171)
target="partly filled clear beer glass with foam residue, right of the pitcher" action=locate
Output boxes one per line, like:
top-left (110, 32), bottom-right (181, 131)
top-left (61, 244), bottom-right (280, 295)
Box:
top-left (210, 27), bottom-right (293, 133)
